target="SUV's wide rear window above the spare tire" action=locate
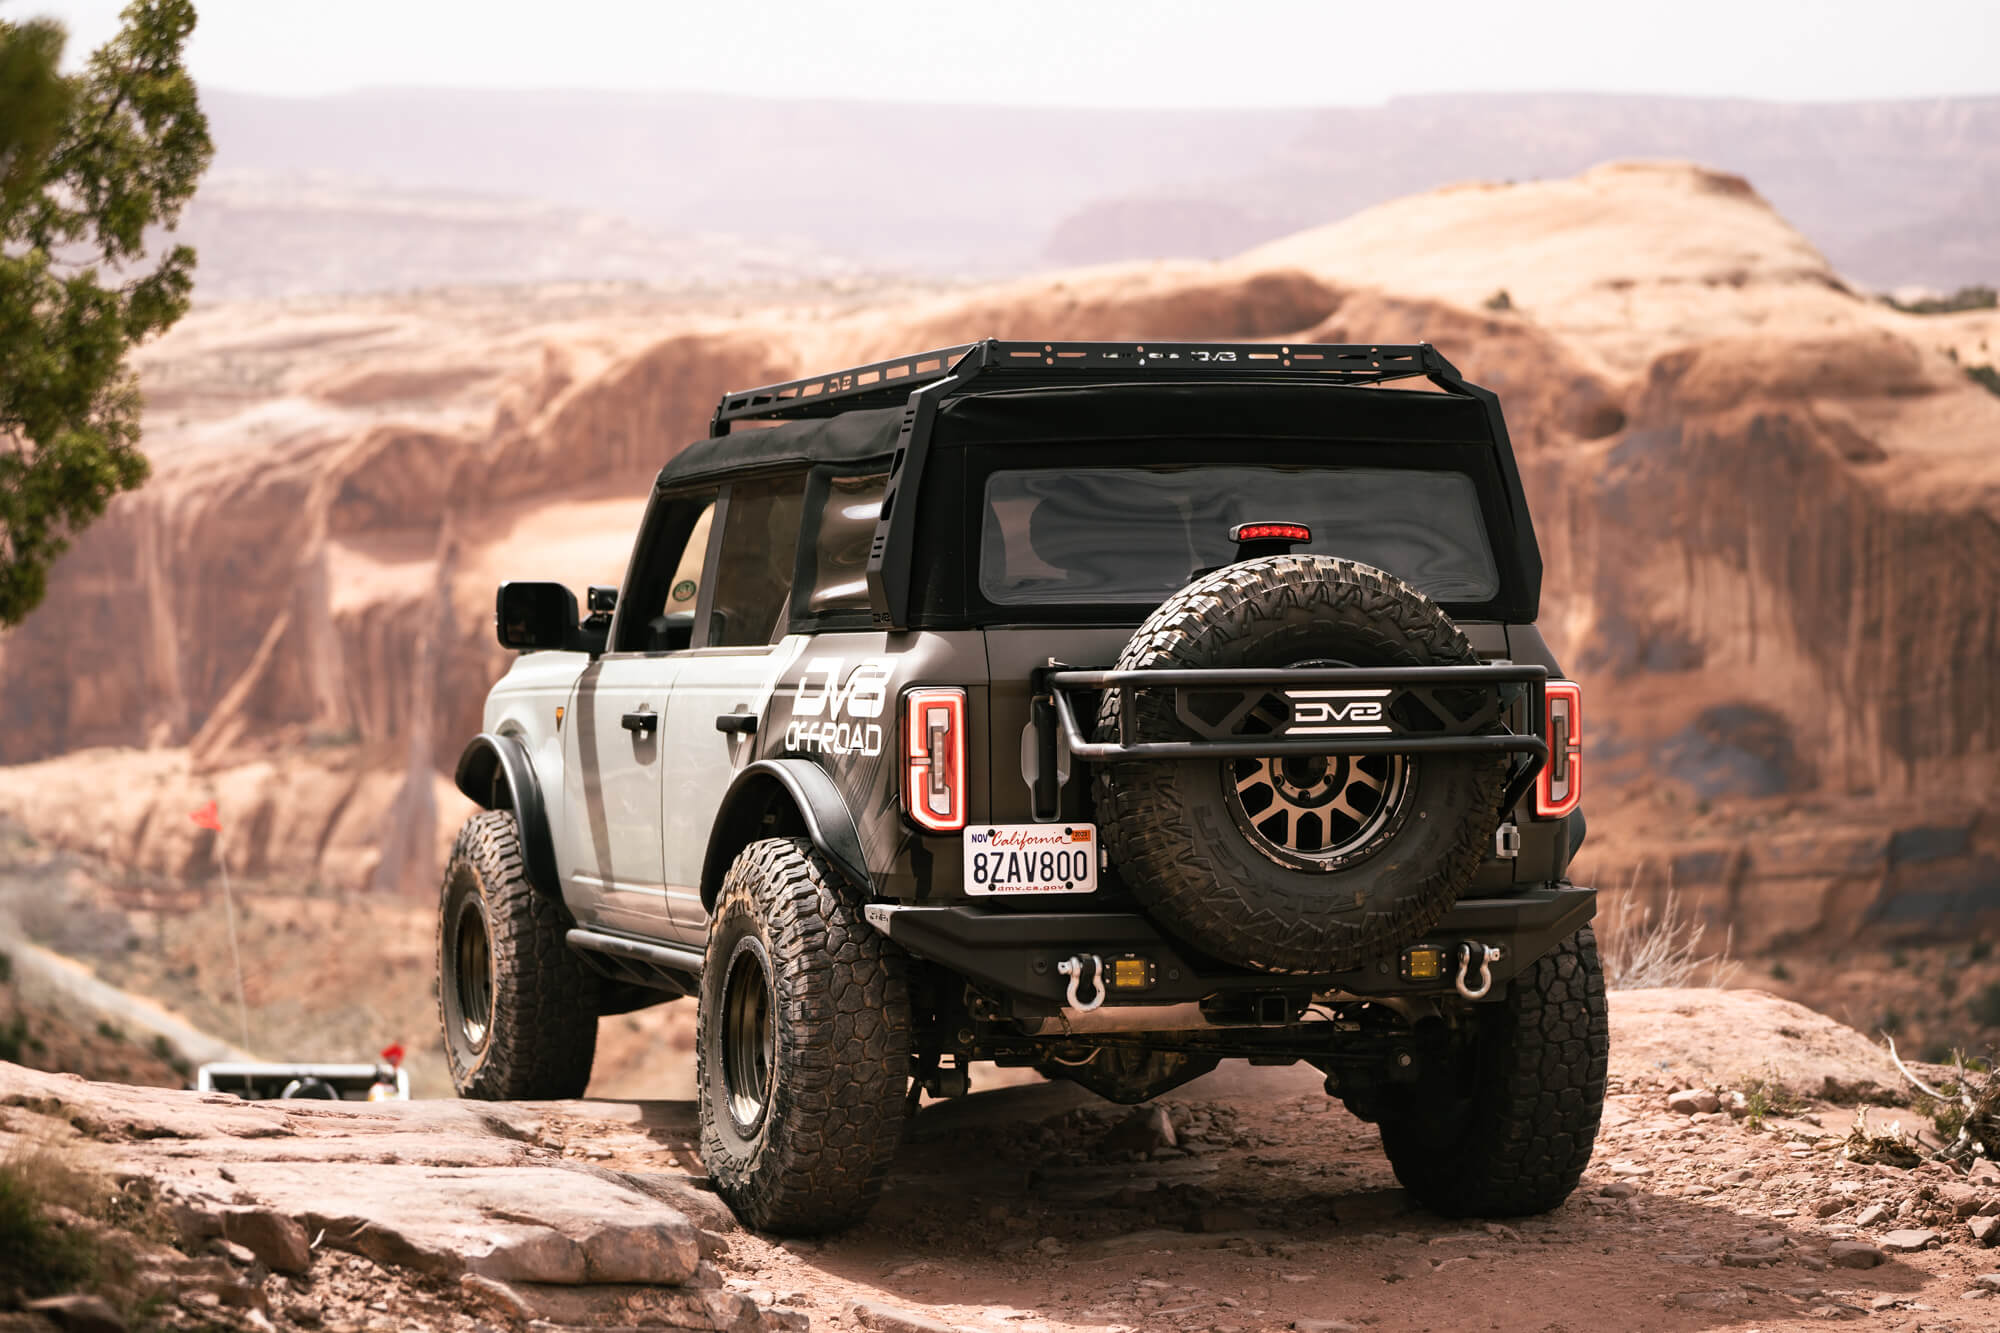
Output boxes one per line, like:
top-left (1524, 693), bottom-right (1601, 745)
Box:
top-left (980, 466), bottom-right (1500, 606)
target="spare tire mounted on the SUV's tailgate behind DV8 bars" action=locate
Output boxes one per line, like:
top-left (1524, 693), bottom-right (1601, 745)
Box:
top-left (1094, 554), bottom-right (1506, 973)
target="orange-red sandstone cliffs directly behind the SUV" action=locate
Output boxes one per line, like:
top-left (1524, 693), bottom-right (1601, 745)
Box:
top-left (0, 164), bottom-right (2000, 960)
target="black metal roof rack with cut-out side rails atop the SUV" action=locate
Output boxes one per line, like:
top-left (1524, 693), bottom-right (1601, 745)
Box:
top-left (708, 338), bottom-right (1458, 436)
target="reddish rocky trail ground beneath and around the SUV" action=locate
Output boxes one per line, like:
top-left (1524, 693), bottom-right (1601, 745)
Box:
top-left (0, 991), bottom-right (2000, 1333)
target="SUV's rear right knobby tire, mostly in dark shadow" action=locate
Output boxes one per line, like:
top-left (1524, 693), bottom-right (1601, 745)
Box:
top-left (1382, 927), bottom-right (1610, 1217)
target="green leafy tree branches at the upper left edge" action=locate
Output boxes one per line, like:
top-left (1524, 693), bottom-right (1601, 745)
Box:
top-left (0, 0), bottom-right (214, 626)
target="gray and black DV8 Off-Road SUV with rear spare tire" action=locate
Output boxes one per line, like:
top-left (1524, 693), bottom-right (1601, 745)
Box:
top-left (438, 340), bottom-right (1606, 1233)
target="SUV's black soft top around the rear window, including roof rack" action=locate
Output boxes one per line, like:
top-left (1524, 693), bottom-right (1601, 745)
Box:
top-left (658, 348), bottom-right (1542, 628)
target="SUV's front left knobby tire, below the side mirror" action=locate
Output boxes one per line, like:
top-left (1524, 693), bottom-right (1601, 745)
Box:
top-left (438, 811), bottom-right (600, 1101)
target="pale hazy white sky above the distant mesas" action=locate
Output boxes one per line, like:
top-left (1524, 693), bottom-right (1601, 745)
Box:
top-left (27, 0), bottom-right (2000, 106)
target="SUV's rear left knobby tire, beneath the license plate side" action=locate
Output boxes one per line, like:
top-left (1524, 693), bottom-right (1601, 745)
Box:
top-left (694, 839), bottom-right (910, 1235)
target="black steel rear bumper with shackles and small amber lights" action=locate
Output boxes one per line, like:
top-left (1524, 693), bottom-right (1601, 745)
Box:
top-left (866, 885), bottom-right (1598, 1017)
